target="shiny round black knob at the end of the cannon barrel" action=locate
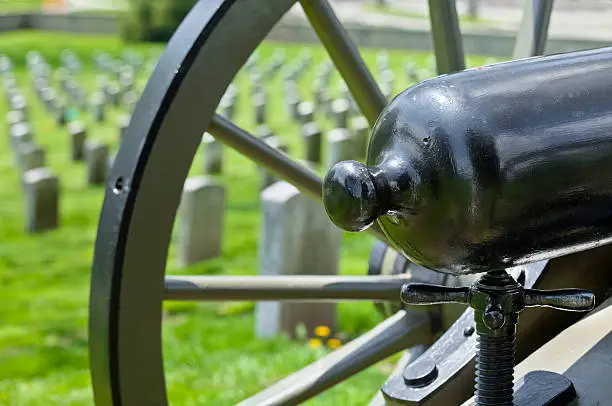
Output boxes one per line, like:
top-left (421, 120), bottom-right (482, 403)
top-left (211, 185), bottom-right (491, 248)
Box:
top-left (323, 161), bottom-right (388, 231)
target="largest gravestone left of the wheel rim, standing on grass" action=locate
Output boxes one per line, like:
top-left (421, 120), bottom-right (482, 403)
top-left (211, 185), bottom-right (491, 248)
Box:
top-left (23, 168), bottom-right (60, 233)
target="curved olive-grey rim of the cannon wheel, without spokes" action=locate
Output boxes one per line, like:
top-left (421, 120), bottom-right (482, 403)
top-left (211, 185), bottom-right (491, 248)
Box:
top-left (89, 0), bottom-right (294, 406)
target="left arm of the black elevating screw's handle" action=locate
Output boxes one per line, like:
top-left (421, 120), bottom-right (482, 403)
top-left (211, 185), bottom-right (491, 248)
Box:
top-left (400, 283), bottom-right (470, 305)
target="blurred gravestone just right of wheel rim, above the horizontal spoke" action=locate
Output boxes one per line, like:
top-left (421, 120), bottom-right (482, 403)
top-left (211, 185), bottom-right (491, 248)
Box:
top-left (178, 176), bottom-right (225, 266)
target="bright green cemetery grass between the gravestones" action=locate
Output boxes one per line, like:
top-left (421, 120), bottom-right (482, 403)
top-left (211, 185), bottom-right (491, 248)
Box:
top-left (0, 31), bottom-right (492, 406)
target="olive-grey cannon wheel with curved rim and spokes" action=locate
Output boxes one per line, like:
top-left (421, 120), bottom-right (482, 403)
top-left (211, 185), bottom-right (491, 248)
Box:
top-left (89, 0), bottom-right (552, 406)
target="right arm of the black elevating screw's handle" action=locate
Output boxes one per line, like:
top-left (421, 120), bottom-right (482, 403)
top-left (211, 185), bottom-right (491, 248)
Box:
top-left (524, 289), bottom-right (595, 312)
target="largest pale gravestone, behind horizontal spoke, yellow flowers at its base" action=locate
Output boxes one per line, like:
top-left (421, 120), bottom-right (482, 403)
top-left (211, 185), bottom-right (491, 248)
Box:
top-left (255, 181), bottom-right (342, 338)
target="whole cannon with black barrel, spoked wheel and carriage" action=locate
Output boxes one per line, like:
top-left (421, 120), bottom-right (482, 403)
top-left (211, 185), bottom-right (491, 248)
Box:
top-left (89, 0), bottom-right (612, 406)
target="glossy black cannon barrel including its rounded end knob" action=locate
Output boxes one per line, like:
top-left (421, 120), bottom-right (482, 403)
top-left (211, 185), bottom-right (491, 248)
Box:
top-left (324, 48), bottom-right (612, 274)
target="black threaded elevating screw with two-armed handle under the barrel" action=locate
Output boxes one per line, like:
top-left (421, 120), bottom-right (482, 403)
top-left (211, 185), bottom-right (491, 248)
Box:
top-left (401, 270), bottom-right (595, 406)
